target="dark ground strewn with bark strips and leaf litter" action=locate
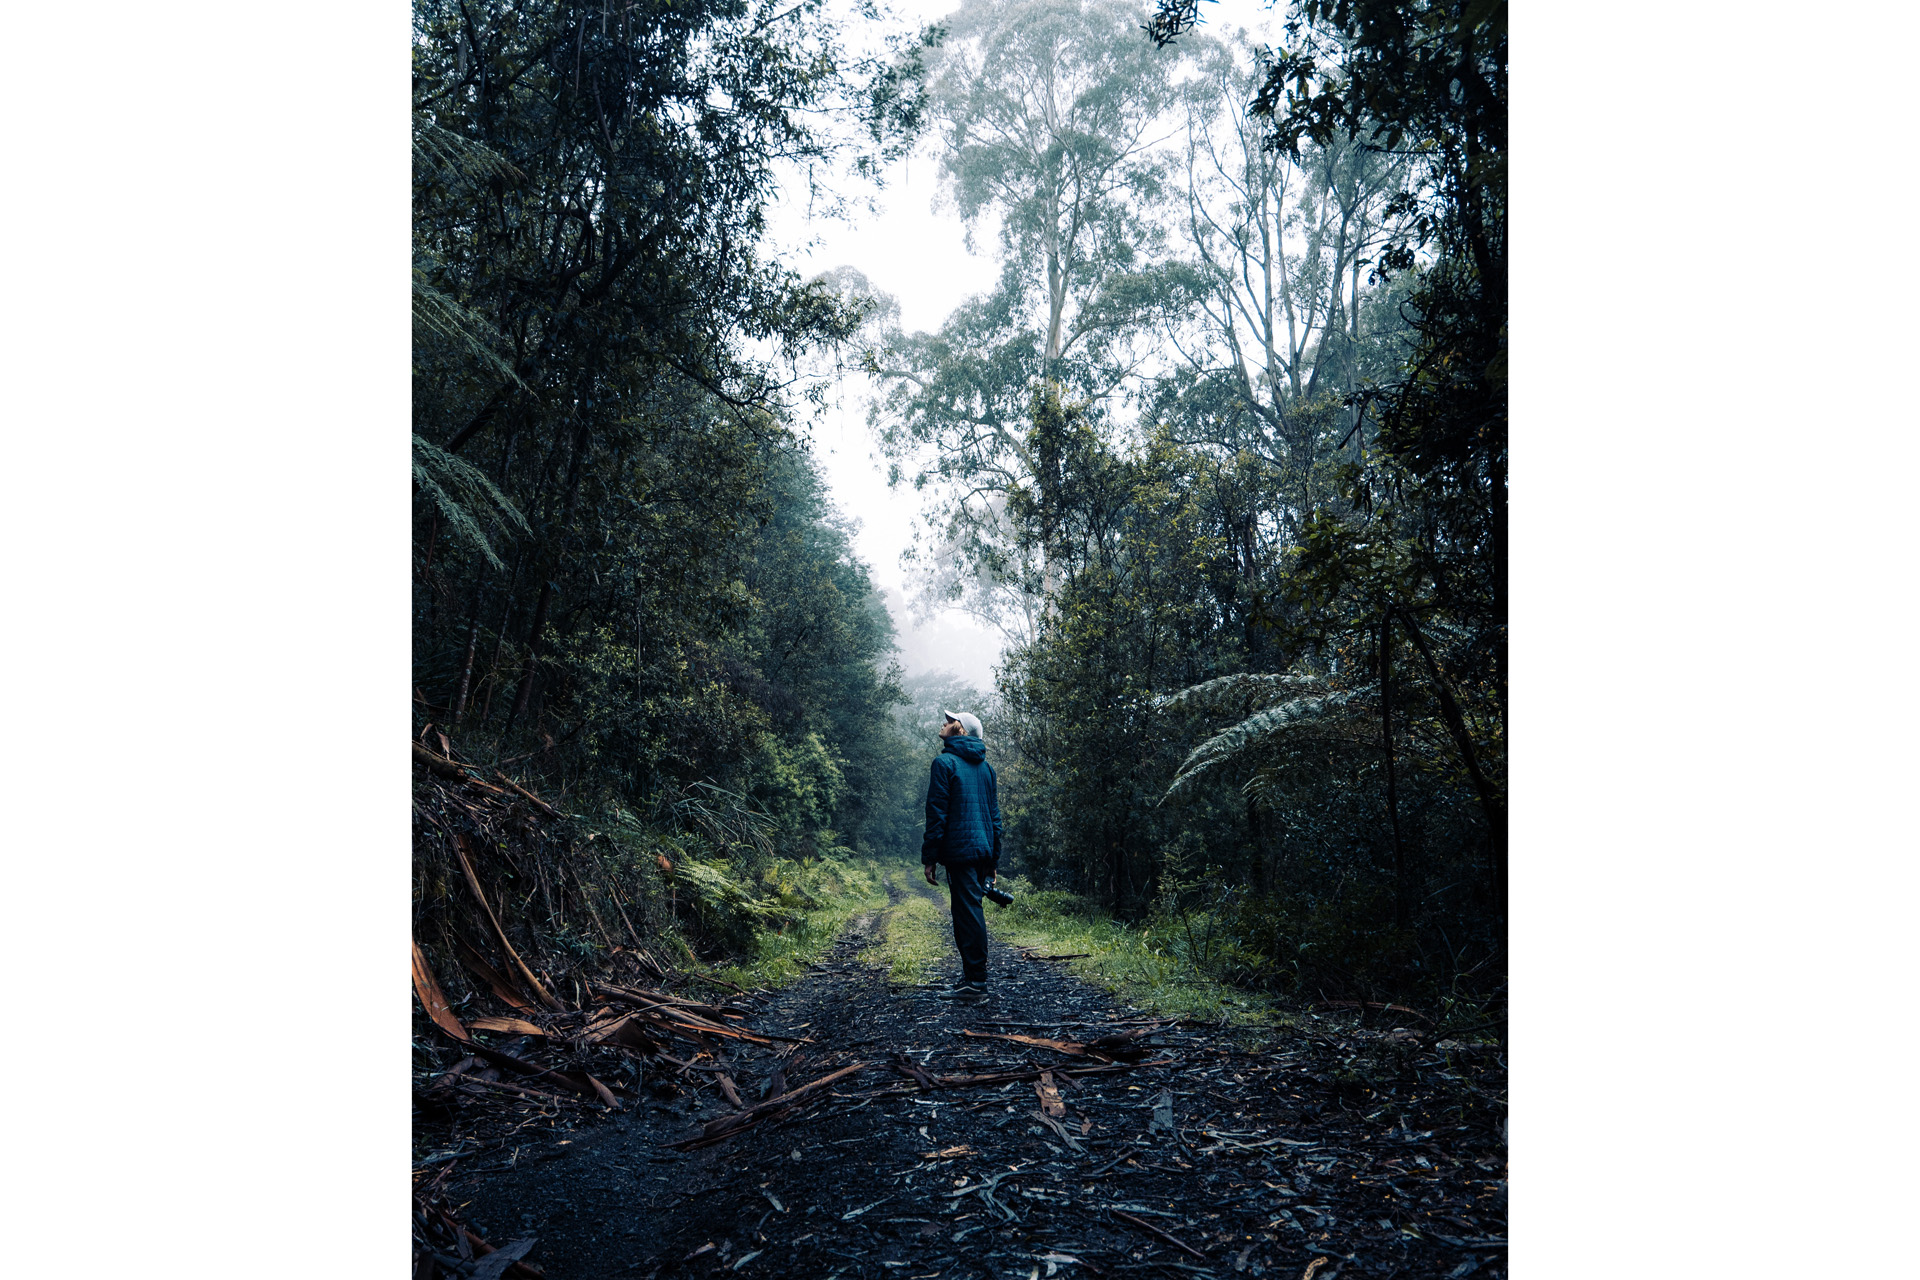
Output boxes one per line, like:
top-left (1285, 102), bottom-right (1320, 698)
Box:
top-left (417, 869), bottom-right (1507, 1280)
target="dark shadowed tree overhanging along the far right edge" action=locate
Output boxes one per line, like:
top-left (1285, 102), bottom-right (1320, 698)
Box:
top-left (1152, 0), bottom-right (1507, 936)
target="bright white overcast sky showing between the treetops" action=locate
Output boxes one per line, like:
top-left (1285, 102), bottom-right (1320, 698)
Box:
top-left (756, 0), bottom-right (1279, 689)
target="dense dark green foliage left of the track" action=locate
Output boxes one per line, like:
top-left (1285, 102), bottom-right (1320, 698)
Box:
top-left (413, 0), bottom-right (944, 959)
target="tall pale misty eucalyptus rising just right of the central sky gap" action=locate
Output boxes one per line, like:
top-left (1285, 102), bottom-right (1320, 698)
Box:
top-left (870, 0), bottom-right (1190, 629)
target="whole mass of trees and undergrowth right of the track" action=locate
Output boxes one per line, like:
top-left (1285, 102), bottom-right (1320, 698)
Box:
top-left (874, 0), bottom-right (1507, 992)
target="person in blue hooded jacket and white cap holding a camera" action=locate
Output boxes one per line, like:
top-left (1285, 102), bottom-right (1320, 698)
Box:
top-left (920, 710), bottom-right (1000, 1004)
